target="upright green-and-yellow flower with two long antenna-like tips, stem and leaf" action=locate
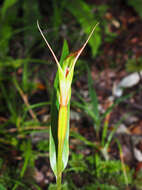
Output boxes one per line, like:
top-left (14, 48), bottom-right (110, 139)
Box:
top-left (37, 22), bottom-right (96, 190)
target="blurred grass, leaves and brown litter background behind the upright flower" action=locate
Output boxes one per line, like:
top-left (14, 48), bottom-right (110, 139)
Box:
top-left (0, 0), bottom-right (142, 190)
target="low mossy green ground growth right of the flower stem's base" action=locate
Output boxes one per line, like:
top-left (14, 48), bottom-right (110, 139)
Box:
top-left (66, 151), bottom-right (133, 190)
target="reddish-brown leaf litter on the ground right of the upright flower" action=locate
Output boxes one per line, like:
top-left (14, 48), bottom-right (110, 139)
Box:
top-left (33, 1), bottom-right (142, 189)
